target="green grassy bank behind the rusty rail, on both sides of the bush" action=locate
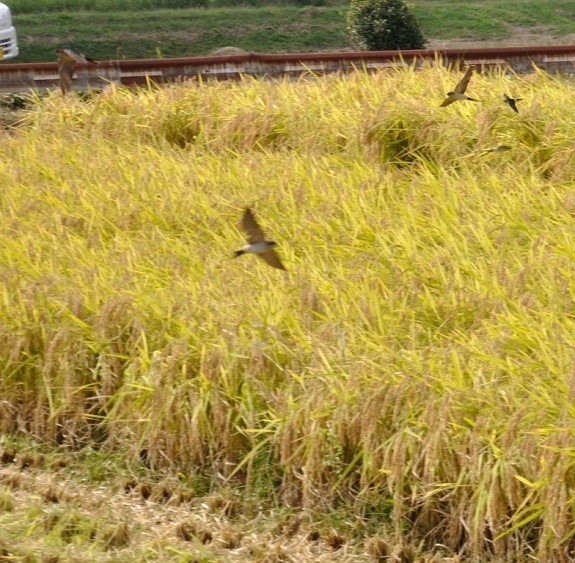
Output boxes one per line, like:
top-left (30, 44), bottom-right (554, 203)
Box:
top-left (6, 0), bottom-right (575, 64)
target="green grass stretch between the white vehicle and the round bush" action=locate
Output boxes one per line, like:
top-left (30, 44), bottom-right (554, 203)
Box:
top-left (7, 6), bottom-right (347, 62)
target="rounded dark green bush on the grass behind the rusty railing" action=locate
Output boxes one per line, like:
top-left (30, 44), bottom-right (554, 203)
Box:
top-left (347, 0), bottom-right (425, 51)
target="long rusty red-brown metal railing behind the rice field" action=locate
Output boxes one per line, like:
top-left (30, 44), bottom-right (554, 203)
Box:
top-left (0, 45), bottom-right (575, 92)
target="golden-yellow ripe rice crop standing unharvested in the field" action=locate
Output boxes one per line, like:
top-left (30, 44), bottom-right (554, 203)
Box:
top-left (0, 68), bottom-right (575, 561)
